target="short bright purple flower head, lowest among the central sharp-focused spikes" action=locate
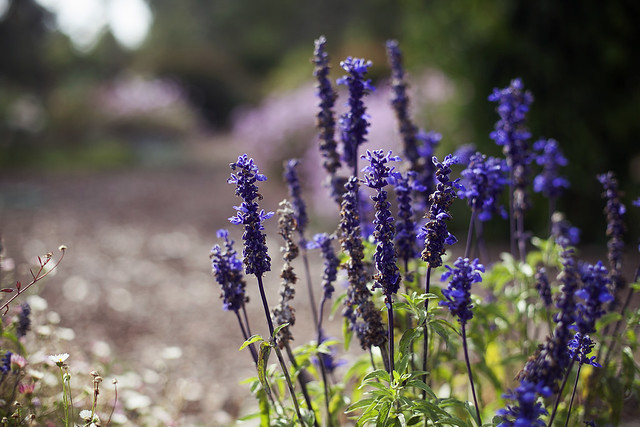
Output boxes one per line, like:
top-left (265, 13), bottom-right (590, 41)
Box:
top-left (440, 257), bottom-right (484, 325)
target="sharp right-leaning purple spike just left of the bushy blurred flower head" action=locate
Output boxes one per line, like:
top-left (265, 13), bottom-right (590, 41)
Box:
top-left (418, 154), bottom-right (461, 267)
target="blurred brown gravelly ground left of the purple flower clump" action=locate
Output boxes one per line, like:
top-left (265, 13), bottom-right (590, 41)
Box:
top-left (0, 140), bottom-right (330, 425)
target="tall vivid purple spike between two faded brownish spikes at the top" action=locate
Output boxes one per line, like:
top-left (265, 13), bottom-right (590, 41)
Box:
top-left (337, 57), bottom-right (375, 176)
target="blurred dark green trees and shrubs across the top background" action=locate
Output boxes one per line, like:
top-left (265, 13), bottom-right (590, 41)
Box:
top-left (0, 0), bottom-right (640, 241)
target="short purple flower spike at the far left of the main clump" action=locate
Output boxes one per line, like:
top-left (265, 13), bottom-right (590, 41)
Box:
top-left (209, 229), bottom-right (249, 312)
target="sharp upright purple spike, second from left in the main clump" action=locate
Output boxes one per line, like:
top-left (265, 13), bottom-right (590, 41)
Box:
top-left (227, 154), bottom-right (273, 276)
